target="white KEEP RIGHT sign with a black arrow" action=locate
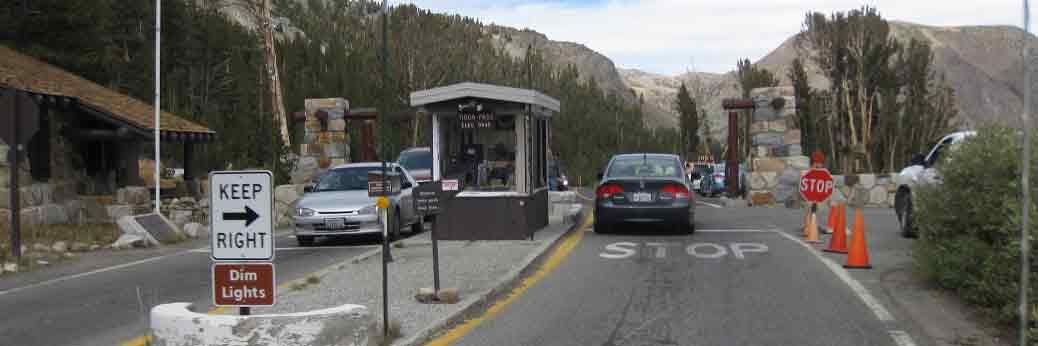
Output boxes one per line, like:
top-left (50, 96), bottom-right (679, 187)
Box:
top-left (209, 170), bottom-right (274, 261)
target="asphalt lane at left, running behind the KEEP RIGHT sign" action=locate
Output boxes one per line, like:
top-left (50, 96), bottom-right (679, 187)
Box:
top-left (0, 228), bottom-right (396, 346)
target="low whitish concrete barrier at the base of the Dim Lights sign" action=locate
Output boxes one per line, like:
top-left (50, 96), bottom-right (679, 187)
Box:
top-left (151, 302), bottom-right (376, 346)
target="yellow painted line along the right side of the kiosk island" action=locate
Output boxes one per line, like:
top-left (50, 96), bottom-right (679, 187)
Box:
top-left (426, 213), bottom-right (592, 346)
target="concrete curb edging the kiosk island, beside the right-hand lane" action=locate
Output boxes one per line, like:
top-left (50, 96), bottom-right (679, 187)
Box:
top-left (393, 207), bottom-right (588, 346)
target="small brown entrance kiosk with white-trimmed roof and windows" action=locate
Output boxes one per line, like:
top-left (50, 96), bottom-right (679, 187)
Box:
top-left (411, 82), bottom-right (559, 240)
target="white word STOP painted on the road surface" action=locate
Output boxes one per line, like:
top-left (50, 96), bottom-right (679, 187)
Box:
top-left (598, 241), bottom-right (768, 260)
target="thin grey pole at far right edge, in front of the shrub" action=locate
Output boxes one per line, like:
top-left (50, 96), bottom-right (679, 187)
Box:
top-left (1018, 0), bottom-right (1032, 346)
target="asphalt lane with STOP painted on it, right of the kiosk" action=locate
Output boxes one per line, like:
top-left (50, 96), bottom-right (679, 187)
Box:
top-left (454, 198), bottom-right (930, 346)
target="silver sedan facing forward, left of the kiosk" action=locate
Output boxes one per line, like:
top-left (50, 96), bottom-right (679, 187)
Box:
top-left (292, 162), bottom-right (421, 246)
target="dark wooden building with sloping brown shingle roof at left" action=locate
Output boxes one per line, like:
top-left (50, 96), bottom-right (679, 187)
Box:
top-left (0, 46), bottom-right (216, 194)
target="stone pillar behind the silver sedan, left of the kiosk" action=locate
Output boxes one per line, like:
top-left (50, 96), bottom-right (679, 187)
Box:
top-left (292, 99), bottom-right (350, 184)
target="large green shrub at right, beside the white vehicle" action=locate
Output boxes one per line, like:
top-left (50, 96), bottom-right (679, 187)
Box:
top-left (912, 125), bottom-right (1038, 341)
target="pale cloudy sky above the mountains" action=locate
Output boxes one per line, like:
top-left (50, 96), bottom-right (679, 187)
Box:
top-left (402, 0), bottom-right (1036, 75)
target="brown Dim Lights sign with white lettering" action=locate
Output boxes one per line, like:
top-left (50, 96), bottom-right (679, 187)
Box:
top-left (212, 262), bottom-right (277, 307)
